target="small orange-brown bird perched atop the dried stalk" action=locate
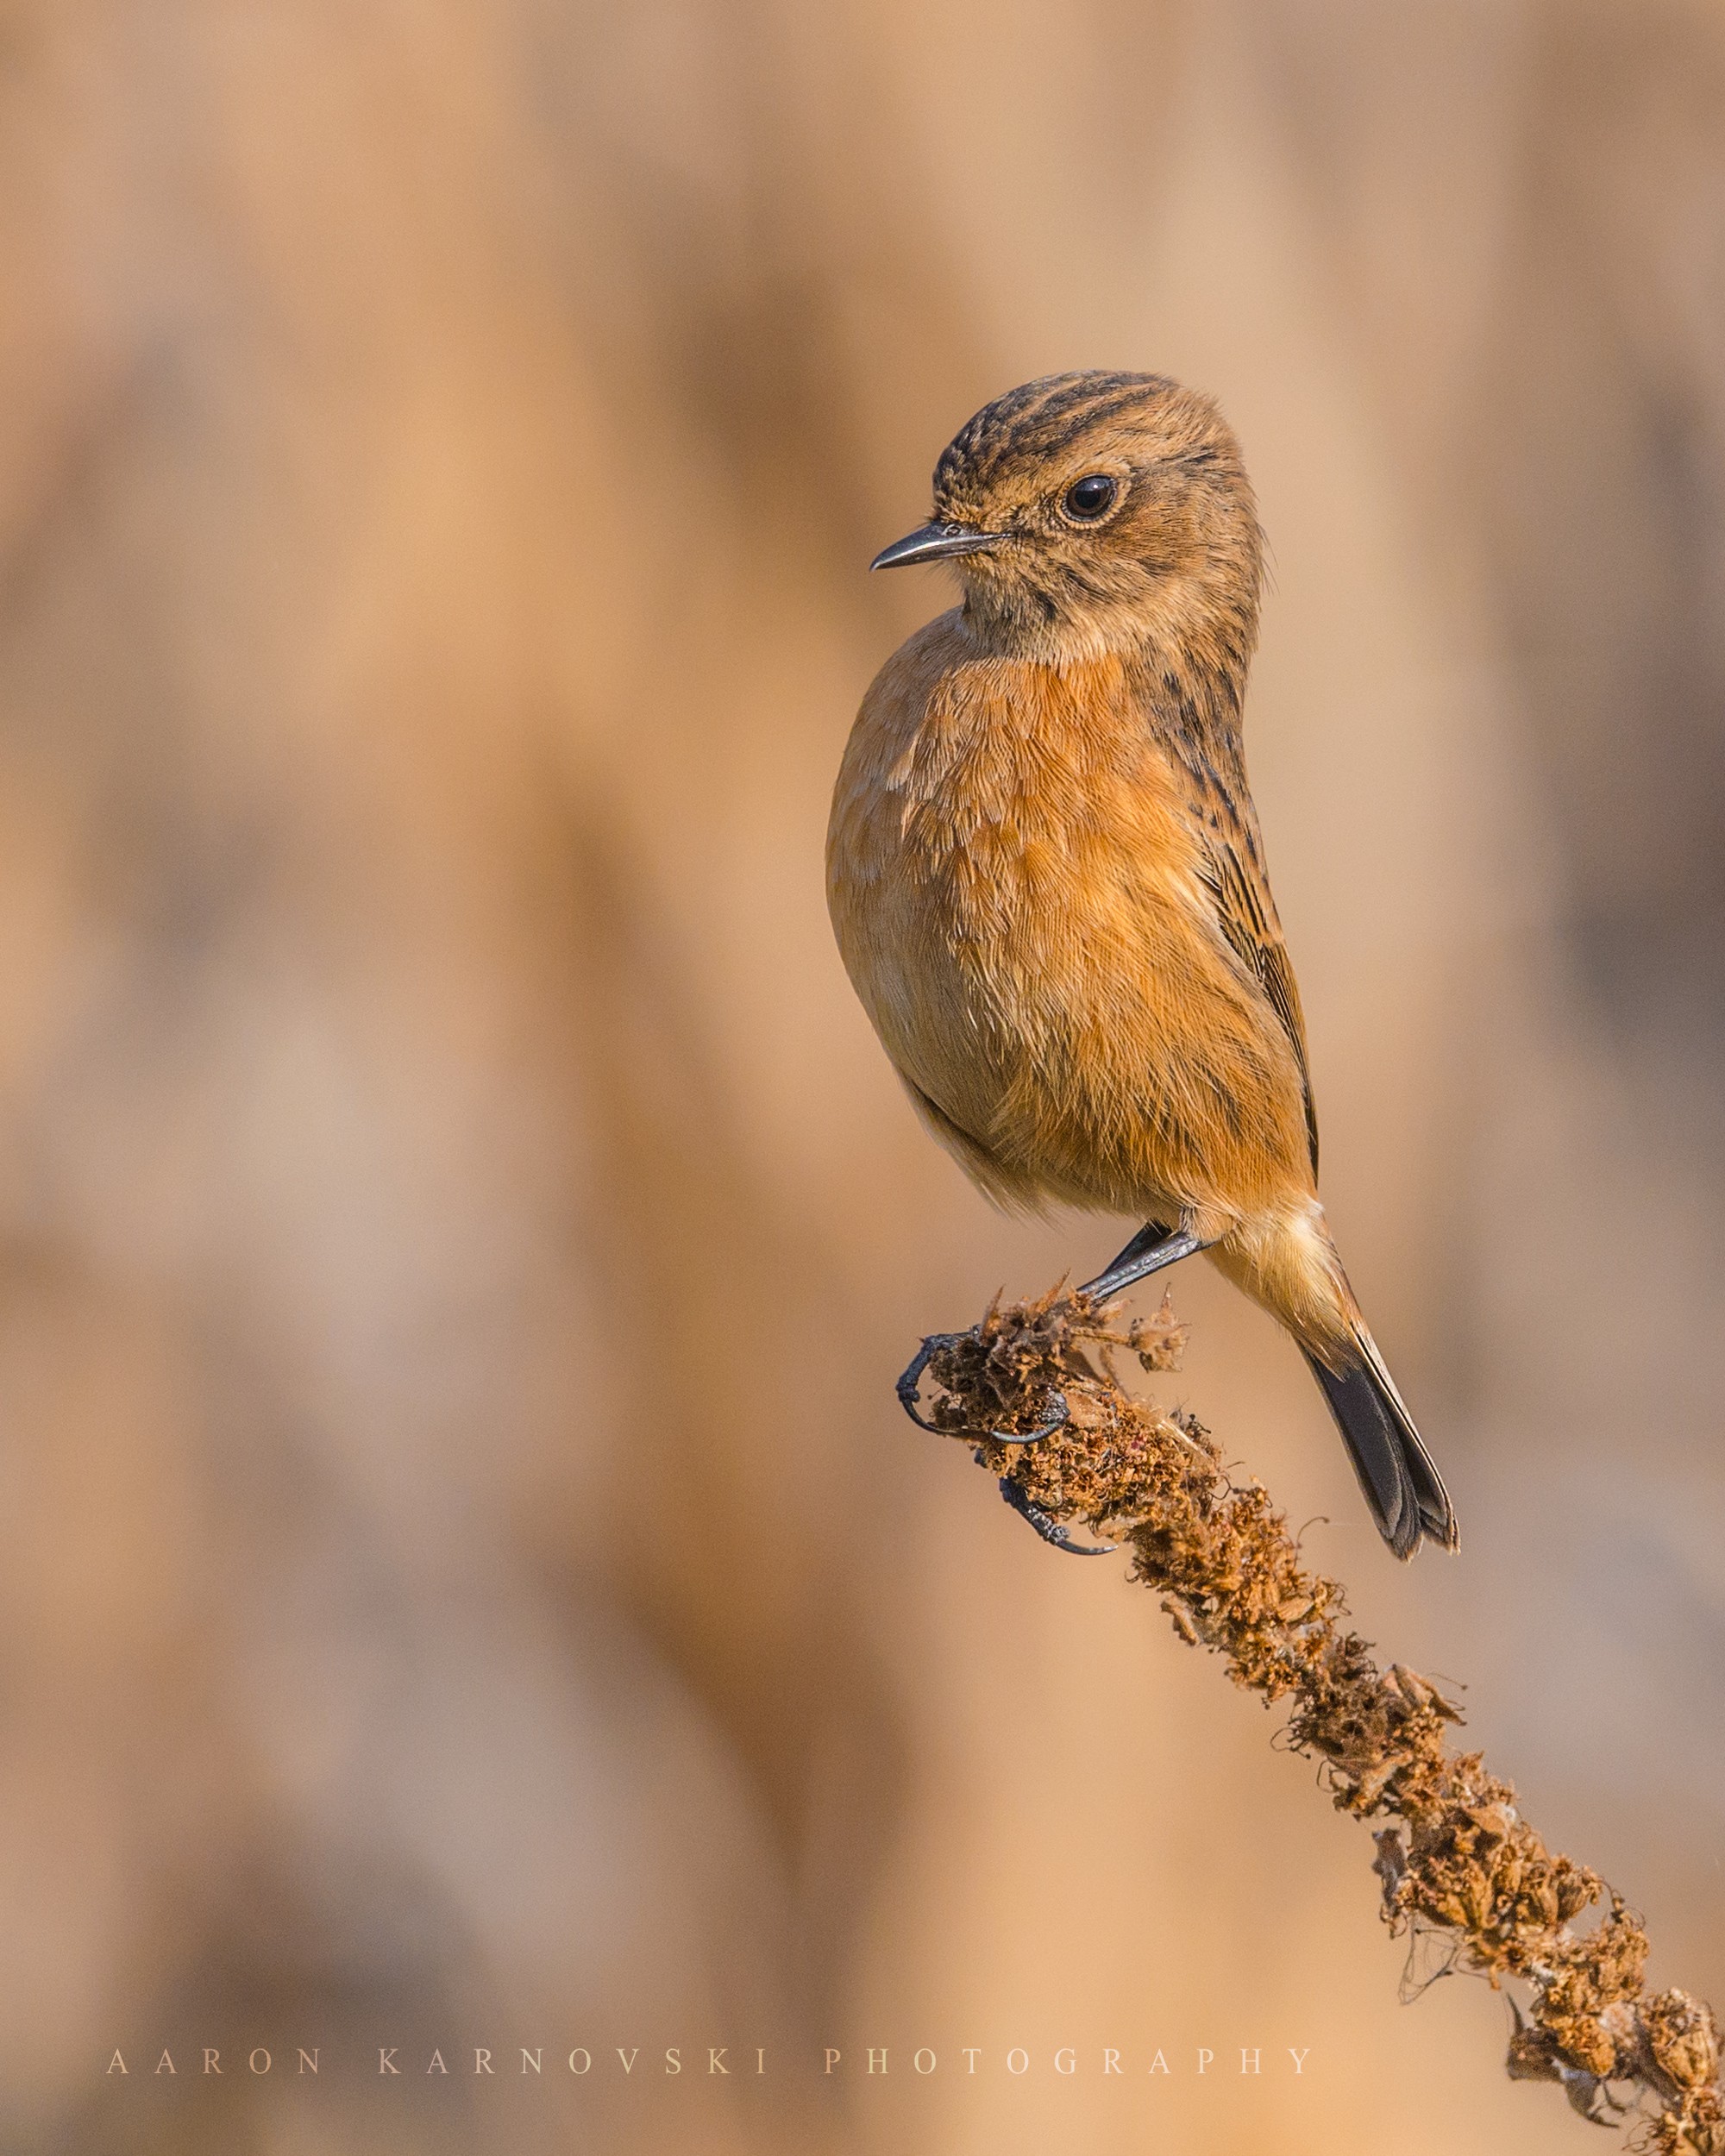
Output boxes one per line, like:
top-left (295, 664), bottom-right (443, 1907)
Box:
top-left (828, 373), bottom-right (1458, 1557)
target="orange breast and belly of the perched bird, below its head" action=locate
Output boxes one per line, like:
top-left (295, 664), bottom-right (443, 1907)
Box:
top-left (828, 612), bottom-right (1311, 1223)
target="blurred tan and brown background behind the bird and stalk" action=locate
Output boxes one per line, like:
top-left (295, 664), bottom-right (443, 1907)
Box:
top-left (0, 0), bottom-right (1725, 2156)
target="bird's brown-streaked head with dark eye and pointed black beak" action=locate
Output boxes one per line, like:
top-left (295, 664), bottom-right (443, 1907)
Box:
top-left (871, 373), bottom-right (1264, 671)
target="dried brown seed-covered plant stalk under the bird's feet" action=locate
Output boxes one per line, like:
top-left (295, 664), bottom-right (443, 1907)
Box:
top-left (914, 1289), bottom-right (1725, 2156)
